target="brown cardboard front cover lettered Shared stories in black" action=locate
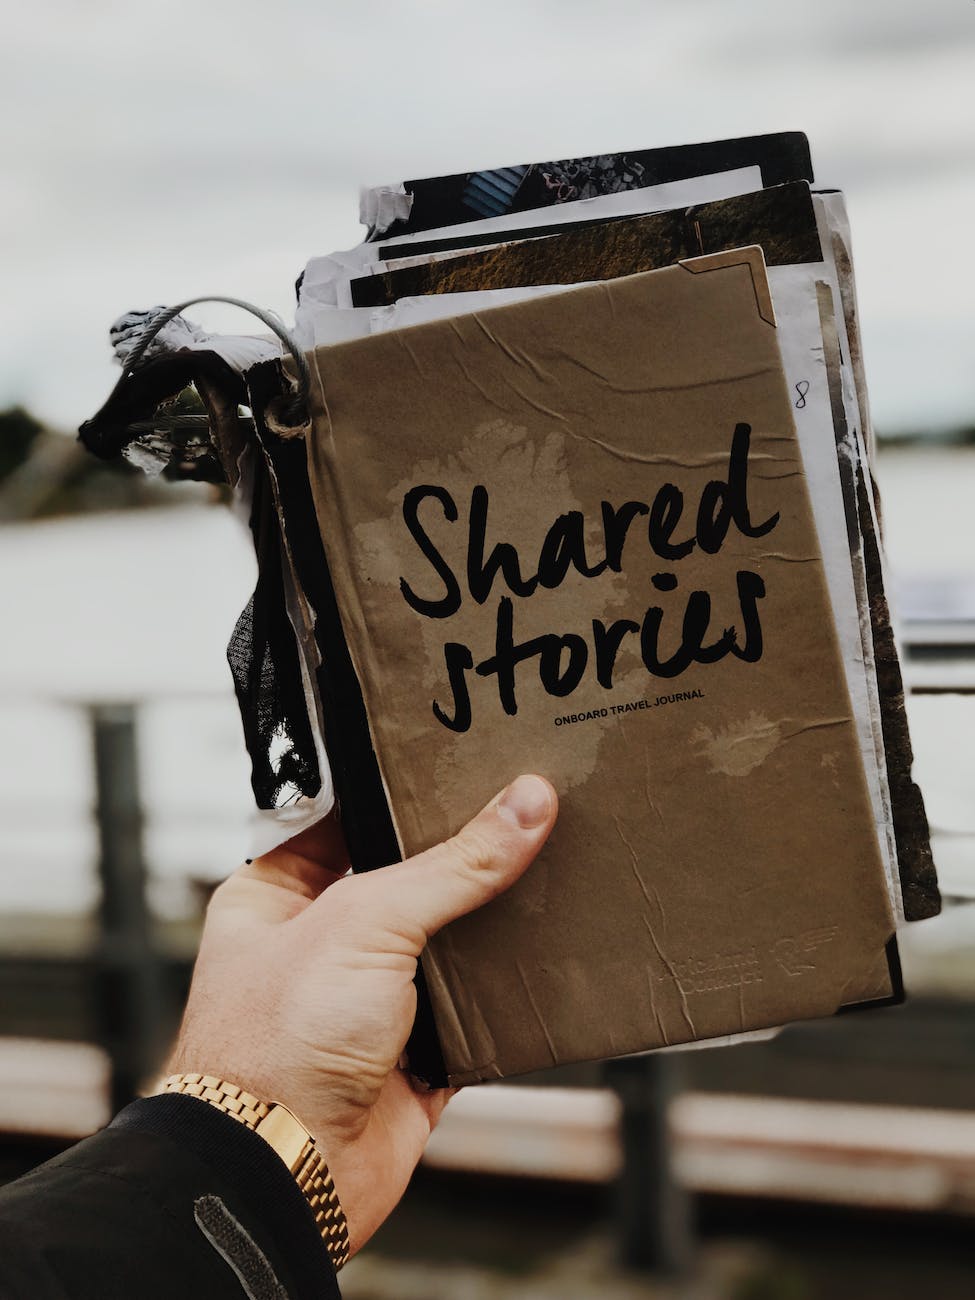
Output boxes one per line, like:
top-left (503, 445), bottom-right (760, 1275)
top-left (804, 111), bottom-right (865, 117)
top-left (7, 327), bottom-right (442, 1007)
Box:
top-left (308, 251), bottom-right (893, 1083)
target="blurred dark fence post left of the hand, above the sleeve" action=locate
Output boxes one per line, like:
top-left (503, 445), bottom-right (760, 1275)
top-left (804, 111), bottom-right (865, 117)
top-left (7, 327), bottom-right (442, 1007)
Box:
top-left (90, 705), bottom-right (164, 1113)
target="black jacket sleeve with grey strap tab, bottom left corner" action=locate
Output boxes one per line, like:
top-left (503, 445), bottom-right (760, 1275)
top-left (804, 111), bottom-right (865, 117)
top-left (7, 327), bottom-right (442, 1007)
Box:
top-left (0, 1096), bottom-right (339, 1300)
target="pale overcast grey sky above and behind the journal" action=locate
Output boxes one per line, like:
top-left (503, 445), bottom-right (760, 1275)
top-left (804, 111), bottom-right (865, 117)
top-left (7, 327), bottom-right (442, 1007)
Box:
top-left (0, 0), bottom-right (975, 430)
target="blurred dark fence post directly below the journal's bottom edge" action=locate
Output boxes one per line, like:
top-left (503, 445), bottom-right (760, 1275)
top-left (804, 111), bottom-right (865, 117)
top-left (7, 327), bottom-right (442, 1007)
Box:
top-left (606, 1056), bottom-right (692, 1277)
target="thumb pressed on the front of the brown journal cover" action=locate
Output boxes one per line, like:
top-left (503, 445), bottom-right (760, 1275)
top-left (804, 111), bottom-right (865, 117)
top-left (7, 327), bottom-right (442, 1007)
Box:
top-left (360, 776), bottom-right (559, 956)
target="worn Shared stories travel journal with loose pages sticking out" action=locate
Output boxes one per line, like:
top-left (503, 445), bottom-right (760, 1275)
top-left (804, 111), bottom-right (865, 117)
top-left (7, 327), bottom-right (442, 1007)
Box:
top-left (91, 133), bottom-right (939, 1084)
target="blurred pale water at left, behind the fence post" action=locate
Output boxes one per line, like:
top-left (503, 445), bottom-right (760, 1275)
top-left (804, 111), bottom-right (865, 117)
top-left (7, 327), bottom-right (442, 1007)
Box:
top-left (0, 507), bottom-right (255, 914)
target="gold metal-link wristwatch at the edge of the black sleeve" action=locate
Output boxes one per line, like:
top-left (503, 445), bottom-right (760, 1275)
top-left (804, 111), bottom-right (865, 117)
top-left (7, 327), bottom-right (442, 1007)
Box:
top-left (159, 1074), bottom-right (348, 1271)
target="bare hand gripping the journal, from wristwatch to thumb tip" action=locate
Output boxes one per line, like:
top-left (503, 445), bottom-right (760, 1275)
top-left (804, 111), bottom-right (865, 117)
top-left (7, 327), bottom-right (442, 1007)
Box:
top-left (169, 776), bottom-right (558, 1253)
